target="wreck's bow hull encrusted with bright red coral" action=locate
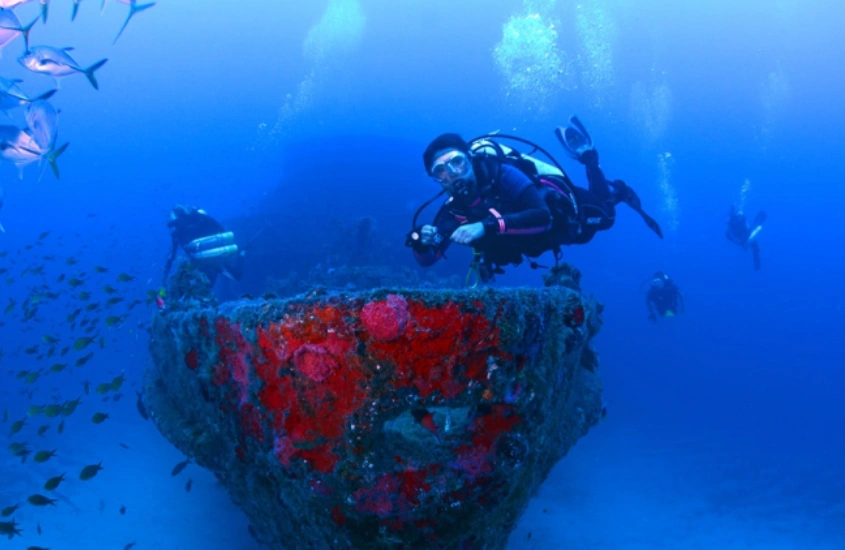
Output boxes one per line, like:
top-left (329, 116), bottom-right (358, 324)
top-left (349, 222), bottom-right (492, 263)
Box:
top-left (145, 288), bottom-right (601, 550)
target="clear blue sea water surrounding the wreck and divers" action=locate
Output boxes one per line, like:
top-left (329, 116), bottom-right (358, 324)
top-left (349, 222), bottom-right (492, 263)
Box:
top-left (0, 0), bottom-right (845, 549)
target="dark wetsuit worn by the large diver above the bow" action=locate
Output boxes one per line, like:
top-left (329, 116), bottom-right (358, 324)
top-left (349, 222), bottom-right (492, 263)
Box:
top-left (413, 156), bottom-right (639, 274)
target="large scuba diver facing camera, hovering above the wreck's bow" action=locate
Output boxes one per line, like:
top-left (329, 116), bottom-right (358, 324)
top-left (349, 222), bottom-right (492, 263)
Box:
top-left (405, 116), bottom-right (663, 286)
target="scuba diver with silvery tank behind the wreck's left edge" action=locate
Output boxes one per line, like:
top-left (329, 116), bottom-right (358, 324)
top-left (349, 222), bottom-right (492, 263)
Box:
top-left (164, 204), bottom-right (244, 286)
